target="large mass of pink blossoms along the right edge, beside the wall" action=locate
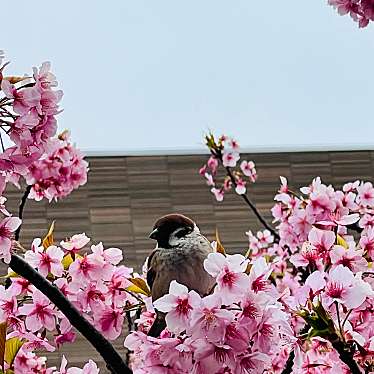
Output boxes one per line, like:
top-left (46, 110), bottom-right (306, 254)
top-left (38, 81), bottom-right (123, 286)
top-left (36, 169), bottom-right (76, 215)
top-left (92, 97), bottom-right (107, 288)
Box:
top-left (266, 177), bottom-right (374, 373)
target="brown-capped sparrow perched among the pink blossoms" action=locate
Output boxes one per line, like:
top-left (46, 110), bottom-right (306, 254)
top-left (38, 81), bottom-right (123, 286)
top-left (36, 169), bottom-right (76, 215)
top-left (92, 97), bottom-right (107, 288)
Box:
top-left (147, 213), bottom-right (215, 337)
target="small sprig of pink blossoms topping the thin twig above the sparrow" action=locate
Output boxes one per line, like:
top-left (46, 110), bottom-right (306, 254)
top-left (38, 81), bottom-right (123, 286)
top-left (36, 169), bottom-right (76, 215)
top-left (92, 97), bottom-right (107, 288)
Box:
top-left (199, 134), bottom-right (257, 201)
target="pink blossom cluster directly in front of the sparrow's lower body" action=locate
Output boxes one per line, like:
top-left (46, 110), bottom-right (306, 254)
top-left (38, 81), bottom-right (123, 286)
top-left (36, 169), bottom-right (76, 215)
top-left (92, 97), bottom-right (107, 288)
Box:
top-left (125, 252), bottom-right (296, 374)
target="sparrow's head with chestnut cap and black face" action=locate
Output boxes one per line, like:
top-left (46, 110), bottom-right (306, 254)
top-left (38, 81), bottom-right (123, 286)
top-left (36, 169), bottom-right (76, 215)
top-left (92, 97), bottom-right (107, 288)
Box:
top-left (149, 213), bottom-right (196, 248)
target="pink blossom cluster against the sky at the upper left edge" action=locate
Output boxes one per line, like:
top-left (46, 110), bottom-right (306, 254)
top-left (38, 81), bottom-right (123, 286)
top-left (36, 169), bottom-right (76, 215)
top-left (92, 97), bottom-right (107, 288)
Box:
top-left (0, 56), bottom-right (62, 188)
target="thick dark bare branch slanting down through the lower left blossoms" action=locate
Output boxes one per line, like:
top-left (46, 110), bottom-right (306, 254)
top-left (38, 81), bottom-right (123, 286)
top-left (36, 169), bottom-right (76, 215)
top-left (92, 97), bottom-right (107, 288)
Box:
top-left (9, 254), bottom-right (132, 374)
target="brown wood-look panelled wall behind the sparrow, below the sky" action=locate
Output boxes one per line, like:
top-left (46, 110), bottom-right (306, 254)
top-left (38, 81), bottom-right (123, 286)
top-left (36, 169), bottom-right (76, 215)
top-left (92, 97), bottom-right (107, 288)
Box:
top-left (7, 151), bottom-right (374, 268)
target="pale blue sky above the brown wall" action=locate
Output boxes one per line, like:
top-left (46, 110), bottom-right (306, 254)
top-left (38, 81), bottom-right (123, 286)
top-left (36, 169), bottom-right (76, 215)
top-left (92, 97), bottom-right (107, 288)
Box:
top-left (0, 0), bottom-right (374, 151)
